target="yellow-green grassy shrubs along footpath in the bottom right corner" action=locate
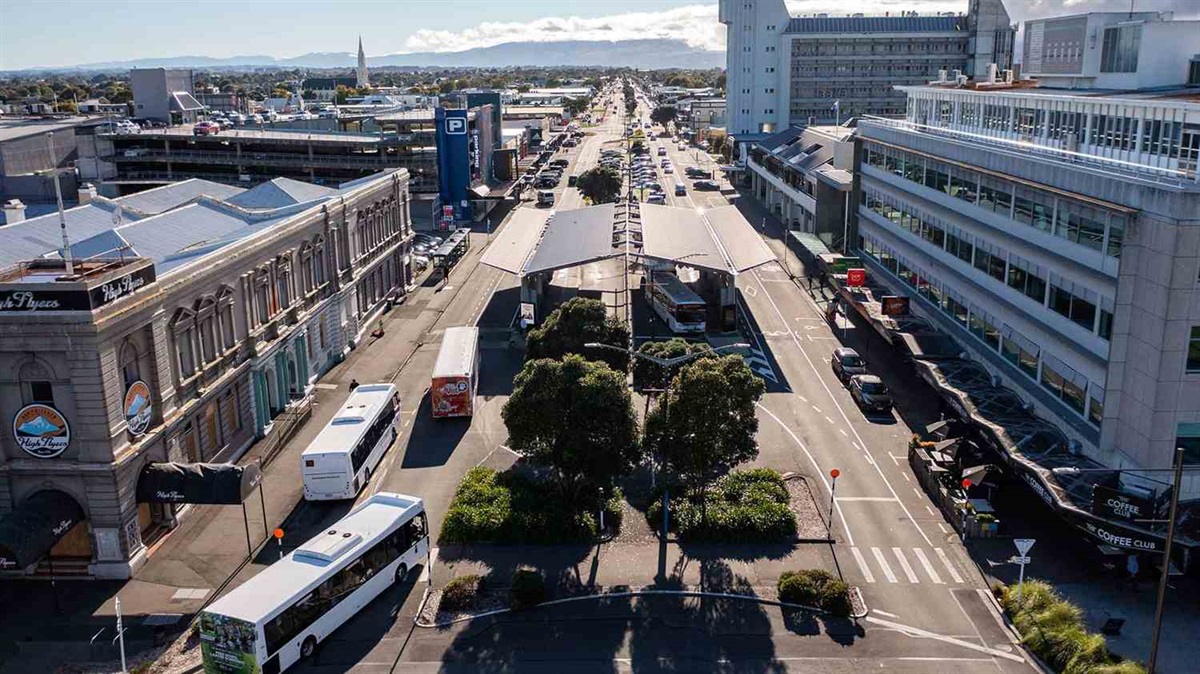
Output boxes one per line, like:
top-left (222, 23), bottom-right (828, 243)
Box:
top-left (1000, 580), bottom-right (1146, 674)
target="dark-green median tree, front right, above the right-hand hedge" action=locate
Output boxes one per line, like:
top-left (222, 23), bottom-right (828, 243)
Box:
top-left (646, 356), bottom-right (766, 512)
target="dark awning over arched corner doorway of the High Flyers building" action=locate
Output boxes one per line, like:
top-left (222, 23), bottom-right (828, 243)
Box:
top-left (0, 491), bottom-right (84, 568)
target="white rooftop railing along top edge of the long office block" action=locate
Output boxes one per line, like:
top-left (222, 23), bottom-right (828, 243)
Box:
top-left (863, 115), bottom-right (1198, 188)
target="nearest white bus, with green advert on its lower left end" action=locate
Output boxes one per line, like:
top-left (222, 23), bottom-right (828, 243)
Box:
top-left (200, 492), bottom-right (430, 674)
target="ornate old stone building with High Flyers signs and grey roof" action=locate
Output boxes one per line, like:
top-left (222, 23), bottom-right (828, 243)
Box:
top-left (0, 170), bottom-right (412, 578)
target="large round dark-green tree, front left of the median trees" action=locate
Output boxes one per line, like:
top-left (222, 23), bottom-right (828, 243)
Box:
top-left (500, 354), bottom-right (637, 503)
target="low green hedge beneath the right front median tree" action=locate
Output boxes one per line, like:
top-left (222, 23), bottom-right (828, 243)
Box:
top-left (646, 468), bottom-right (796, 543)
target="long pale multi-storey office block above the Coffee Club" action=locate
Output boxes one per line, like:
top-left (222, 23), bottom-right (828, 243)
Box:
top-left (856, 12), bottom-right (1200, 513)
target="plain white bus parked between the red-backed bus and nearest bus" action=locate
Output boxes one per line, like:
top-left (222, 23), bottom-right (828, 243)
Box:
top-left (300, 384), bottom-right (400, 501)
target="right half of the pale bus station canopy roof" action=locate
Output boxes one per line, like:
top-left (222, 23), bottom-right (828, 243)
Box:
top-left (641, 204), bottom-right (775, 276)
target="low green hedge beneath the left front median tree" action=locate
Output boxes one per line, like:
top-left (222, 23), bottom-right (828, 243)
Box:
top-left (439, 467), bottom-right (622, 543)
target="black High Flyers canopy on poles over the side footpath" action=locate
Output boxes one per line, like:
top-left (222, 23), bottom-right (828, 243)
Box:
top-left (138, 463), bottom-right (263, 505)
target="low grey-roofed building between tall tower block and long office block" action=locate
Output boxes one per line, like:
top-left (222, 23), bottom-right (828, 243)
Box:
top-left (745, 121), bottom-right (854, 249)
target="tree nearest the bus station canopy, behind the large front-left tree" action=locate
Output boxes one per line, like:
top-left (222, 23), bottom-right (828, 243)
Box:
top-left (526, 297), bottom-right (629, 372)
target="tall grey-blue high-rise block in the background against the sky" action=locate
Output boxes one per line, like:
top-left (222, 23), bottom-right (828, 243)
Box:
top-left (719, 0), bottom-right (1015, 142)
